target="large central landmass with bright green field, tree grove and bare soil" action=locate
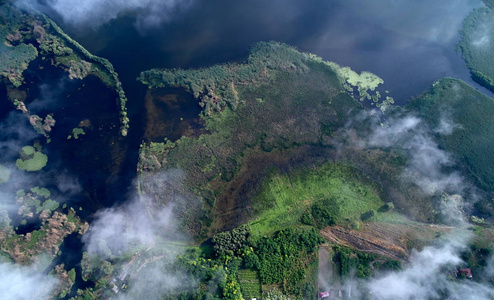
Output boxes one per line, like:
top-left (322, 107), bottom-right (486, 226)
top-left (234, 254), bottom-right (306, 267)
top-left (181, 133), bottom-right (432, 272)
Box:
top-left (127, 42), bottom-right (493, 299)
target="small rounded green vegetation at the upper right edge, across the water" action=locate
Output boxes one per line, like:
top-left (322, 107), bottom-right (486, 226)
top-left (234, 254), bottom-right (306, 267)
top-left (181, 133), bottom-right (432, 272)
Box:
top-left (459, 5), bottom-right (494, 92)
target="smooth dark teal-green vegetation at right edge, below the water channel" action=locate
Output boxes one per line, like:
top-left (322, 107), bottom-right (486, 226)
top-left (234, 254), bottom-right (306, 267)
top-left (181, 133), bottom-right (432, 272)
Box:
top-left (409, 79), bottom-right (494, 191)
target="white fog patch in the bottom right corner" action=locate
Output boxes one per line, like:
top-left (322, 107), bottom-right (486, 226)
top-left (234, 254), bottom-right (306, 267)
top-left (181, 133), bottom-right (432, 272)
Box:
top-left (366, 230), bottom-right (494, 300)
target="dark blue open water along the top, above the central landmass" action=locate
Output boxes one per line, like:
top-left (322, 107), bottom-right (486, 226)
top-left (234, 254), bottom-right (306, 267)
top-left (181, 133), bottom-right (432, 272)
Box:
top-left (50, 0), bottom-right (481, 102)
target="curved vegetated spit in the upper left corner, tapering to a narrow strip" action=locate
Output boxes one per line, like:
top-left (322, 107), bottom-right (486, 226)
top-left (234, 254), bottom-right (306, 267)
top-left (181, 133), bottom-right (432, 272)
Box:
top-left (0, 1), bottom-right (129, 136)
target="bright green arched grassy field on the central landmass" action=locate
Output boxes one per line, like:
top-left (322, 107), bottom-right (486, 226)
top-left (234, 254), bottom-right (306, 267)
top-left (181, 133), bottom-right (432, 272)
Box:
top-left (250, 164), bottom-right (382, 236)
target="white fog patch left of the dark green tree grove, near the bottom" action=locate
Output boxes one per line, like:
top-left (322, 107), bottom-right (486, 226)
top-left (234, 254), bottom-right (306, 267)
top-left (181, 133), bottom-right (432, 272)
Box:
top-left (83, 171), bottom-right (197, 299)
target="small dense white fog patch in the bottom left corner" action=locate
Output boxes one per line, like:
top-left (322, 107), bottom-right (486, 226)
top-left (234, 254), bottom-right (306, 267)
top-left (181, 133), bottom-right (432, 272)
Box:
top-left (0, 263), bottom-right (58, 300)
